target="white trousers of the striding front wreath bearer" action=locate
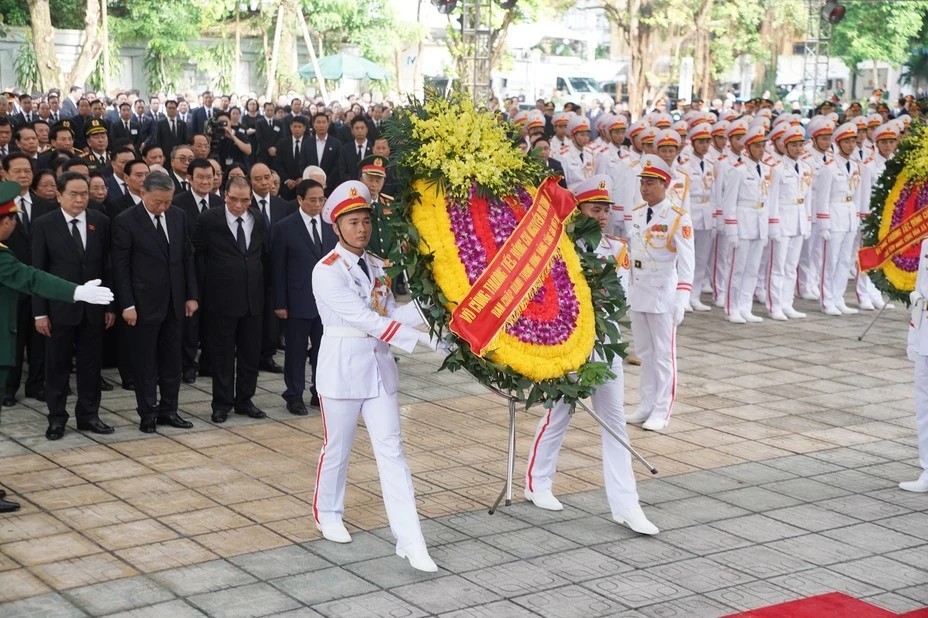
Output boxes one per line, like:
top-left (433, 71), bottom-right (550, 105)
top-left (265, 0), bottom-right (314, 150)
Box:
top-left (313, 390), bottom-right (425, 548)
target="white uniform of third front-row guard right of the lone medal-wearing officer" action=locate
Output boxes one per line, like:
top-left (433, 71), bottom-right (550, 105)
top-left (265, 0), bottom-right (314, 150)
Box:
top-left (764, 157), bottom-right (813, 316)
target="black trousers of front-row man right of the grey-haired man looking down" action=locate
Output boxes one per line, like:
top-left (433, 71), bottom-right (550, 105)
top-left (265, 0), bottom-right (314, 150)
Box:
top-left (207, 314), bottom-right (262, 412)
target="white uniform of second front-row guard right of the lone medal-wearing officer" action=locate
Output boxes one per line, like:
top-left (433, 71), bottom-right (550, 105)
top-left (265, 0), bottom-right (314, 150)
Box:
top-left (720, 157), bottom-right (776, 319)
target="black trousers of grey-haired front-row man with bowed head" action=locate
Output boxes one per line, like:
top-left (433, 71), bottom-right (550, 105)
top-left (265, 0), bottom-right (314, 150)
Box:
top-left (127, 311), bottom-right (182, 419)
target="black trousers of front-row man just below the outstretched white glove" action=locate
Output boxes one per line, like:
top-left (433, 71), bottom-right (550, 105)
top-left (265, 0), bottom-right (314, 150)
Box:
top-left (45, 311), bottom-right (105, 425)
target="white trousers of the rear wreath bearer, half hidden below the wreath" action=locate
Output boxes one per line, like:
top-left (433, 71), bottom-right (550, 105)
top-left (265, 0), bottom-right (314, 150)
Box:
top-left (525, 358), bottom-right (638, 513)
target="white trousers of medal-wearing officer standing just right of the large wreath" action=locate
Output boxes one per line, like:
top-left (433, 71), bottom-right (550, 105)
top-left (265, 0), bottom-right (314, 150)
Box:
top-left (628, 311), bottom-right (677, 420)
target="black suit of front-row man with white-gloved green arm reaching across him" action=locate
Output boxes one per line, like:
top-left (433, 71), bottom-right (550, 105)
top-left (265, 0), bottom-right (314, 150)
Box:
top-left (32, 210), bottom-right (113, 425)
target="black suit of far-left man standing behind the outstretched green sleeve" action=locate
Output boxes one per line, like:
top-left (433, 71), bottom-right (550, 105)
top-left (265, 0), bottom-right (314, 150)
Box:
top-left (4, 191), bottom-right (57, 397)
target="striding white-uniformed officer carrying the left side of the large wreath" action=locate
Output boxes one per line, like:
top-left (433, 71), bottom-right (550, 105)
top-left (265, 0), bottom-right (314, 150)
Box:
top-left (312, 180), bottom-right (438, 572)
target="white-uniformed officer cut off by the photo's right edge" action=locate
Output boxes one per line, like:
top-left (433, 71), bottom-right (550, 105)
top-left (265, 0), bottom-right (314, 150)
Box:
top-left (899, 239), bottom-right (928, 493)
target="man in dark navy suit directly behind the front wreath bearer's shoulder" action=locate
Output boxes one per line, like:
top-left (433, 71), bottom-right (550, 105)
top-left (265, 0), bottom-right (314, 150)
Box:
top-left (271, 180), bottom-right (338, 416)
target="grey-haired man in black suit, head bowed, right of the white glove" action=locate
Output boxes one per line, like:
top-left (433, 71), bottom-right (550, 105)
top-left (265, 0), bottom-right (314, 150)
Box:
top-left (112, 172), bottom-right (199, 433)
